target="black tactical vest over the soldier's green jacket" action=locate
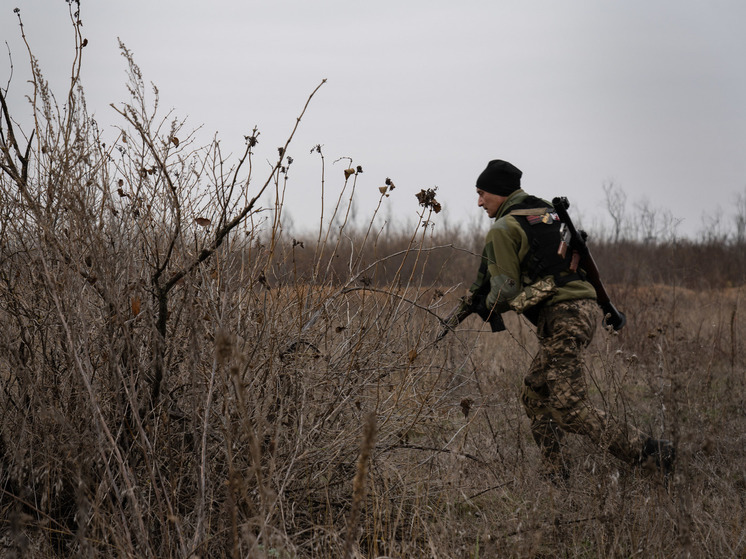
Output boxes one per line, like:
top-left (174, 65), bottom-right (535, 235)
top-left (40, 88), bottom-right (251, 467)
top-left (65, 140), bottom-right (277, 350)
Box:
top-left (508, 196), bottom-right (585, 286)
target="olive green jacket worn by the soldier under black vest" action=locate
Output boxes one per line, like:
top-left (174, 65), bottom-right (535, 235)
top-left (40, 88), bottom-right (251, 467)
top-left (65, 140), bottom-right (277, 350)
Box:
top-left (469, 189), bottom-right (596, 313)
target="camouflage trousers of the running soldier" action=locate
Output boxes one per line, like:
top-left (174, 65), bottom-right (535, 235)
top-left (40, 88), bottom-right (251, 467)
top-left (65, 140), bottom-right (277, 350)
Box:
top-left (521, 299), bottom-right (646, 467)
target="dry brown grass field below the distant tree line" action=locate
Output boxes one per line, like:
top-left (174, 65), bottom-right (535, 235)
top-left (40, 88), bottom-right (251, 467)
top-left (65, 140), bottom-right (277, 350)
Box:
top-left (1, 250), bottom-right (746, 557)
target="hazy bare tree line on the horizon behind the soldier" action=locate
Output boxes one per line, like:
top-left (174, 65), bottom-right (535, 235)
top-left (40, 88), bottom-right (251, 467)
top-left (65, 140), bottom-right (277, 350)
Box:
top-left (274, 181), bottom-right (746, 289)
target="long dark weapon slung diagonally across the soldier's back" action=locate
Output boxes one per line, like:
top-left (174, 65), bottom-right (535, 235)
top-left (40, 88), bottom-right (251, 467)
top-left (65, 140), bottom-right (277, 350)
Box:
top-left (552, 196), bottom-right (627, 330)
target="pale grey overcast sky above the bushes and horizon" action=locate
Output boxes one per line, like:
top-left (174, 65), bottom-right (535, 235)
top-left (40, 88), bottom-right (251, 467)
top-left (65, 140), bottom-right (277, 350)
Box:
top-left (0, 0), bottom-right (746, 240)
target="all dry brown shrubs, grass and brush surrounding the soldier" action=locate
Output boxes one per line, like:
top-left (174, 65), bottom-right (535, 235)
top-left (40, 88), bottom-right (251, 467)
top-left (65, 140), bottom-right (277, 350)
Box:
top-left (0, 6), bottom-right (746, 558)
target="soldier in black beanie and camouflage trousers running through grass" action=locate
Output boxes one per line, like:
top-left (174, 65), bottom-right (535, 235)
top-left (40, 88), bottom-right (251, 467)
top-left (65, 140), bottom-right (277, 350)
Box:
top-left (440, 159), bottom-right (674, 478)
